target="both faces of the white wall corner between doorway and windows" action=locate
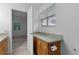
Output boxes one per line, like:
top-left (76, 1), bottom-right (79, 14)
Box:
top-left (27, 4), bottom-right (42, 54)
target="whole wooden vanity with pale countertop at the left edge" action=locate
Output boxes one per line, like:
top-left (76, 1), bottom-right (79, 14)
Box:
top-left (0, 34), bottom-right (8, 55)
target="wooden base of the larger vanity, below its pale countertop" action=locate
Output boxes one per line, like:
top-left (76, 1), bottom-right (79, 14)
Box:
top-left (34, 36), bottom-right (60, 55)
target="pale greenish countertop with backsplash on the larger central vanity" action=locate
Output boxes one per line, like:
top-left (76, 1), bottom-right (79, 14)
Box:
top-left (32, 32), bottom-right (63, 43)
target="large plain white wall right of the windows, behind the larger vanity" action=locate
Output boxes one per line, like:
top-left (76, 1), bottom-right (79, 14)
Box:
top-left (39, 3), bottom-right (79, 54)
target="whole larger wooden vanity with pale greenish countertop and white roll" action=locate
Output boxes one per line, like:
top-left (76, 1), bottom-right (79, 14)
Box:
top-left (33, 33), bottom-right (63, 55)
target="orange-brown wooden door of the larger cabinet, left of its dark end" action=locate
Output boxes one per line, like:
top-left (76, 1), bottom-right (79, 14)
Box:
top-left (37, 39), bottom-right (48, 55)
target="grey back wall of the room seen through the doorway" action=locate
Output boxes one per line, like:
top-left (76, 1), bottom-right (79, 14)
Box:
top-left (12, 11), bottom-right (27, 36)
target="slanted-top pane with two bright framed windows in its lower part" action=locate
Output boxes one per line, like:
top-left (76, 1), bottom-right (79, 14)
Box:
top-left (40, 4), bottom-right (56, 26)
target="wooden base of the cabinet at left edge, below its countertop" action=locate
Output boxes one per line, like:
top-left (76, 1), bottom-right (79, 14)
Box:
top-left (0, 38), bottom-right (8, 55)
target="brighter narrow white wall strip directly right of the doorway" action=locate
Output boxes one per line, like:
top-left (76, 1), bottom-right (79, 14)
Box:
top-left (27, 6), bottom-right (33, 54)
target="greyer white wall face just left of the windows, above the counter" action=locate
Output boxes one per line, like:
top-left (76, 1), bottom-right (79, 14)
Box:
top-left (33, 5), bottom-right (39, 32)
